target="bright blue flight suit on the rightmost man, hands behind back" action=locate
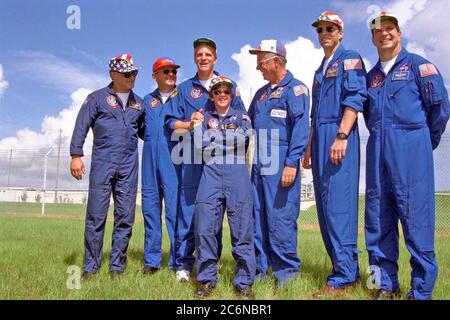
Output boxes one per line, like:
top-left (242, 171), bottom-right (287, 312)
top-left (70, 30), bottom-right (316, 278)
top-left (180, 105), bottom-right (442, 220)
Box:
top-left (364, 49), bottom-right (450, 299)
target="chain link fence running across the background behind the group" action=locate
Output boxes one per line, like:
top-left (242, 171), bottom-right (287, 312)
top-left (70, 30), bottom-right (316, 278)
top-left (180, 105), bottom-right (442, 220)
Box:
top-left (0, 136), bottom-right (450, 236)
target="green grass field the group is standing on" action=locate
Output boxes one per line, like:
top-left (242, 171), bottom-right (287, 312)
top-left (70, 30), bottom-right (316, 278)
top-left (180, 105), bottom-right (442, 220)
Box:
top-left (0, 199), bottom-right (450, 300)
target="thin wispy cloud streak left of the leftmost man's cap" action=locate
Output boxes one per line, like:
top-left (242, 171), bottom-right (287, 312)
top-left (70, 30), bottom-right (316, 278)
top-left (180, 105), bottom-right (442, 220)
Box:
top-left (17, 51), bottom-right (109, 93)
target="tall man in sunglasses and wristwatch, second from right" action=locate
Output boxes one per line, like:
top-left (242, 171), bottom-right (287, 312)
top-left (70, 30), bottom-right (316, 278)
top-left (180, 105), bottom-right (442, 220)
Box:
top-left (303, 11), bottom-right (367, 298)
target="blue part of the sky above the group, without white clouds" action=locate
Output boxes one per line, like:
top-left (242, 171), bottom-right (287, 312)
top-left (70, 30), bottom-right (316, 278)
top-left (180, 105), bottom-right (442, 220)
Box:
top-left (0, 0), bottom-right (420, 139)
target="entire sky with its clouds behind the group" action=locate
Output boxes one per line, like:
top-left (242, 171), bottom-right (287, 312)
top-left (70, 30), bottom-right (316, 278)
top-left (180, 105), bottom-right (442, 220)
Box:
top-left (0, 0), bottom-right (450, 189)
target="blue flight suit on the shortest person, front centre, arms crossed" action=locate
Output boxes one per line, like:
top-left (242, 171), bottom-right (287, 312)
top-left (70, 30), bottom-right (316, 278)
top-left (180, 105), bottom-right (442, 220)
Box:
top-left (194, 105), bottom-right (256, 288)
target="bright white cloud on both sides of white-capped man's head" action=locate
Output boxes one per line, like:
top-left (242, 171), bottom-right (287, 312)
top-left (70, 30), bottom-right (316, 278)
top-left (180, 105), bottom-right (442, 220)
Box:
top-left (231, 36), bottom-right (323, 108)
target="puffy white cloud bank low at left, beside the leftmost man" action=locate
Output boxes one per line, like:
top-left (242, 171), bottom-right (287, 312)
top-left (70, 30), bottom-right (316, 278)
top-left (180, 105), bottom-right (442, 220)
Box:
top-left (0, 88), bottom-right (92, 189)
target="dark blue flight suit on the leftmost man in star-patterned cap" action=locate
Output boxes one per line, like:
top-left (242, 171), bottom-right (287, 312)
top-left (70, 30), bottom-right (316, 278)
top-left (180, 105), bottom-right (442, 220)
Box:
top-left (70, 83), bottom-right (143, 272)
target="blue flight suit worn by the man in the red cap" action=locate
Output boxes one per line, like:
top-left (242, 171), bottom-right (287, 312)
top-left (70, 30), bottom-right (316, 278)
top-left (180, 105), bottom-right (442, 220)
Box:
top-left (142, 89), bottom-right (180, 269)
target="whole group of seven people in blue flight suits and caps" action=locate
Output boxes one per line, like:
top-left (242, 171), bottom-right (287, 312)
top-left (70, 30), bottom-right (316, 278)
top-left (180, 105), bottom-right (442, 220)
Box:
top-left (70, 11), bottom-right (450, 299)
